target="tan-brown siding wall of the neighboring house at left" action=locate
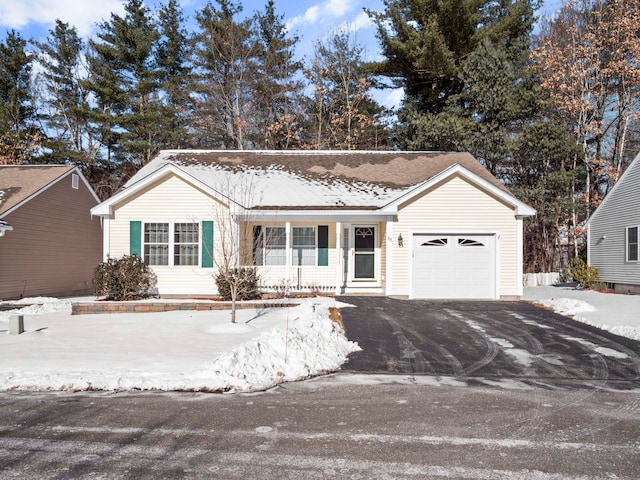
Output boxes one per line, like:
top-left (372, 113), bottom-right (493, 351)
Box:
top-left (0, 173), bottom-right (102, 300)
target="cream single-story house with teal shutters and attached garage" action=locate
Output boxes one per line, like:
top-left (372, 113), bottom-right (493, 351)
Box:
top-left (92, 150), bottom-right (535, 299)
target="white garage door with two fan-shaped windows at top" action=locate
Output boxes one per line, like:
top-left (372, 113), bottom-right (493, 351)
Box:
top-left (411, 234), bottom-right (496, 298)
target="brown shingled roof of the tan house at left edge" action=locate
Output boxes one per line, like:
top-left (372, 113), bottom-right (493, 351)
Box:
top-left (0, 165), bottom-right (84, 215)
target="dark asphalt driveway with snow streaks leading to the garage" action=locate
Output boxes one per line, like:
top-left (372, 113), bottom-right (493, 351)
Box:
top-left (340, 296), bottom-right (640, 391)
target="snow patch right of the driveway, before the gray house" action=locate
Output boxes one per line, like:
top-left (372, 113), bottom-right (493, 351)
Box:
top-left (522, 285), bottom-right (640, 340)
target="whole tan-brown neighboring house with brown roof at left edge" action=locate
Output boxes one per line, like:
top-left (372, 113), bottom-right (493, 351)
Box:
top-left (0, 165), bottom-right (102, 300)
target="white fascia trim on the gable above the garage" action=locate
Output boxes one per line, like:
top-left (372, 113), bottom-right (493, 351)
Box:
top-left (381, 164), bottom-right (536, 217)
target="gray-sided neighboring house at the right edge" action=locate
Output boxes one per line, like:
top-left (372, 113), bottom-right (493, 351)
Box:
top-left (587, 154), bottom-right (640, 294)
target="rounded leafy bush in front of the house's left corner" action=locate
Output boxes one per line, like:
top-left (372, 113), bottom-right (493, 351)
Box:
top-left (93, 255), bottom-right (157, 301)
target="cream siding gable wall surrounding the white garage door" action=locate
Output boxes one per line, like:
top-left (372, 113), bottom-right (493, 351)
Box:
top-left (391, 176), bottom-right (522, 297)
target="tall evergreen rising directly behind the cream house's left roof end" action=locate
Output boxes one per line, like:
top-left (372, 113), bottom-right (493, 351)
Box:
top-left (89, 0), bottom-right (163, 166)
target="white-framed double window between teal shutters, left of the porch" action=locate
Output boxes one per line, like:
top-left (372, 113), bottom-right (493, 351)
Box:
top-left (144, 223), bottom-right (200, 266)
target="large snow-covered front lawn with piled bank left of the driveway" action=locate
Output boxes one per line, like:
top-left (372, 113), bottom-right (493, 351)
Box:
top-left (0, 297), bottom-right (359, 392)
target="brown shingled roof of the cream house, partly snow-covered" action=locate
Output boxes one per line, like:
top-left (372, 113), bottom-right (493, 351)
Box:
top-left (121, 150), bottom-right (511, 210)
